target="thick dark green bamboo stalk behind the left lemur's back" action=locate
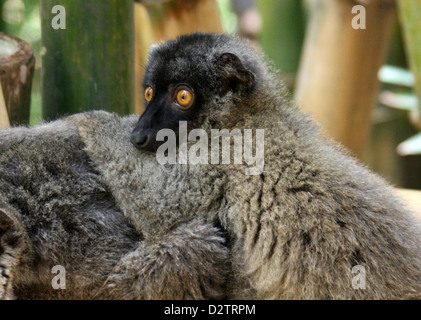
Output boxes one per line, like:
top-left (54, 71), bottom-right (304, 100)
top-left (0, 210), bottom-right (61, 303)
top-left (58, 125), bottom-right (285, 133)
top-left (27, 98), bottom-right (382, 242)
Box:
top-left (40, 0), bottom-right (134, 119)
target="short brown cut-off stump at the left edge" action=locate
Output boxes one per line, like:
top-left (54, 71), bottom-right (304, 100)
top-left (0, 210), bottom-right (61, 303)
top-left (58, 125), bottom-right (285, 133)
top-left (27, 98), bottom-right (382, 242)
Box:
top-left (0, 33), bottom-right (35, 125)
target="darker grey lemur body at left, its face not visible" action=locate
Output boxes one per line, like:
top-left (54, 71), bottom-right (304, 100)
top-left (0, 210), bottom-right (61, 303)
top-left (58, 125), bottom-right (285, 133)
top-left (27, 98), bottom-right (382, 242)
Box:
top-left (0, 115), bottom-right (228, 299)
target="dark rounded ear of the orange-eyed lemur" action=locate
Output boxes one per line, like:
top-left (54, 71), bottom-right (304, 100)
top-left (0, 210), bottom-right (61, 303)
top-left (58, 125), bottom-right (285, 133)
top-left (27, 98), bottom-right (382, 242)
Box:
top-left (215, 52), bottom-right (255, 92)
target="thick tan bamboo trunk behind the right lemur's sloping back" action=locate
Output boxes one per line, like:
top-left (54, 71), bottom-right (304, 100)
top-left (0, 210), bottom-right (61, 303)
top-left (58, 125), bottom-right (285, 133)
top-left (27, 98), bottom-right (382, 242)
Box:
top-left (295, 0), bottom-right (395, 157)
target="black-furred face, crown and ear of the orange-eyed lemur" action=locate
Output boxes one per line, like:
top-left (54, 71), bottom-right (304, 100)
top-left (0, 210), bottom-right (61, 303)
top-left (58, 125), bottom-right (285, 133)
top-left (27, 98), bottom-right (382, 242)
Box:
top-left (131, 34), bottom-right (254, 151)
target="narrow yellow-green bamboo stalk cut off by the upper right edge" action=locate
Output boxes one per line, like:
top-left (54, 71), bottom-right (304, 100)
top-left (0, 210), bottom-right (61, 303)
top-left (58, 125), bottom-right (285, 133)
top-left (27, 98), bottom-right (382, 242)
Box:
top-left (398, 0), bottom-right (421, 123)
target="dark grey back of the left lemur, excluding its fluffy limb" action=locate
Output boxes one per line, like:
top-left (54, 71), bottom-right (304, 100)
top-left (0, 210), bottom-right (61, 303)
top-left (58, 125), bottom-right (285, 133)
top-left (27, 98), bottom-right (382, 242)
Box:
top-left (0, 120), bottom-right (139, 299)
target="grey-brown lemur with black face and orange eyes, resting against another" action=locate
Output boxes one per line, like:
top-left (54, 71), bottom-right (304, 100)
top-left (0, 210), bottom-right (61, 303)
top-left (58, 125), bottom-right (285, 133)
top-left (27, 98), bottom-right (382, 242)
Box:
top-left (129, 33), bottom-right (421, 299)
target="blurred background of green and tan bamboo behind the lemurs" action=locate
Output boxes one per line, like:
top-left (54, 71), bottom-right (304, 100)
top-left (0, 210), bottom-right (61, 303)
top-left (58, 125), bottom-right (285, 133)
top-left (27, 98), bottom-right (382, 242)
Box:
top-left (0, 0), bottom-right (421, 189)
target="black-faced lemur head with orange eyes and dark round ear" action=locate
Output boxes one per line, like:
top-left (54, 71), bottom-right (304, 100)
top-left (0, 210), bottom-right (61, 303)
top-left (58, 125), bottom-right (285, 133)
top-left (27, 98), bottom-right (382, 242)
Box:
top-left (131, 33), bottom-right (262, 151)
